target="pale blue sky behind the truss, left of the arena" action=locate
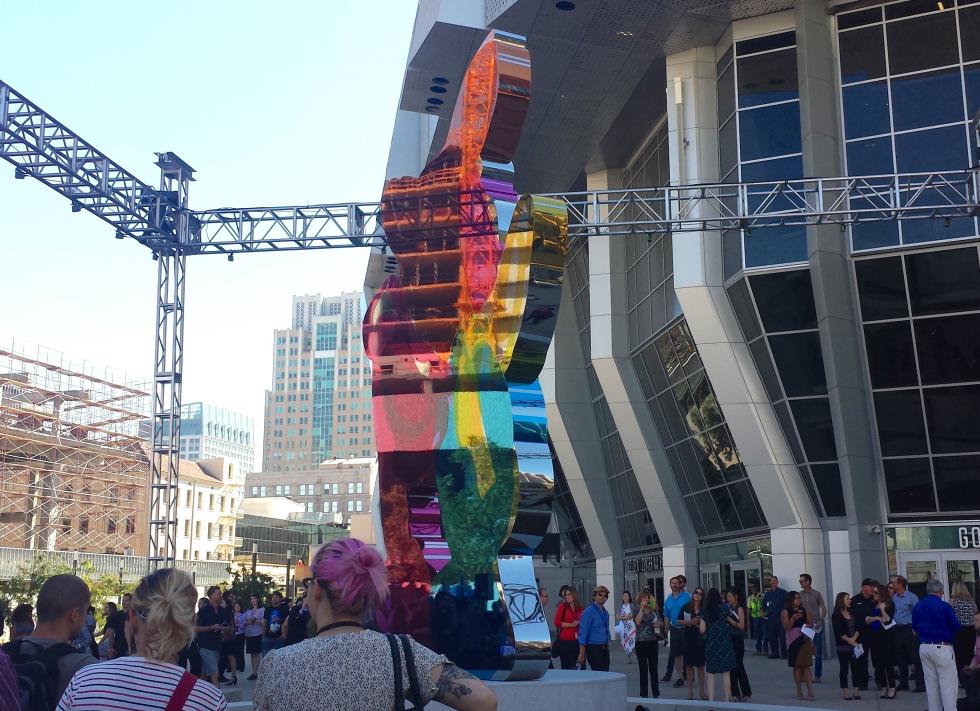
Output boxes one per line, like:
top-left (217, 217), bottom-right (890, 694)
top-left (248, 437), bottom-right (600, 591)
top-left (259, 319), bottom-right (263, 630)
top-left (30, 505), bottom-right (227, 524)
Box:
top-left (0, 0), bottom-right (416, 458)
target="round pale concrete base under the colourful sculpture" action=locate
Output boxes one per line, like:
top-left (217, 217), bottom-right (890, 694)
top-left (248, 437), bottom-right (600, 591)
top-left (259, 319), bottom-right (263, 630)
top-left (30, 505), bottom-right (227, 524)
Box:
top-left (425, 669), bottom-right (626, 711)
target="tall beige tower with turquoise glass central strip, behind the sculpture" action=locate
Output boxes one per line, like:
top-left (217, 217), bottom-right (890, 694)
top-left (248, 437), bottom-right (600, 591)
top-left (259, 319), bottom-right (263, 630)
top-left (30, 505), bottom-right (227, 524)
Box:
top-left (262, 291), bottom-right (374, 473)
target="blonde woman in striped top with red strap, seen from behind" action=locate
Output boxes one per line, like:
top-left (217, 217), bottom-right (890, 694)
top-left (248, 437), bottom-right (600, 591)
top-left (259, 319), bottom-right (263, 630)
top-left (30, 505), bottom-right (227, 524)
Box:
top-left (58, 568), bottom-right (228, 711)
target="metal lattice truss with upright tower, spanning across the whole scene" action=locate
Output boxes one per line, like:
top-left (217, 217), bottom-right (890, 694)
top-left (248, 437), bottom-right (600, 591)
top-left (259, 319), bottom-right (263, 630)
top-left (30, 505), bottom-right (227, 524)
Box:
top-left (0, 76), bottom-right (980, 567)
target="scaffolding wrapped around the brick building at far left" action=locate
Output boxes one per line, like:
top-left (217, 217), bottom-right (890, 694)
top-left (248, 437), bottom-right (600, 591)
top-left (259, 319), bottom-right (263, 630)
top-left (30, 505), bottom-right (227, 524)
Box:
top-left (0, 347), bottom-right (150, 555)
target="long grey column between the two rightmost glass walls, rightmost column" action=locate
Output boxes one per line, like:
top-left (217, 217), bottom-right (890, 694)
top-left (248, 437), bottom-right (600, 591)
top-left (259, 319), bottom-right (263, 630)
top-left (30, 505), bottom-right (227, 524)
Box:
top-left (796, 0), bottom-right (887, 590)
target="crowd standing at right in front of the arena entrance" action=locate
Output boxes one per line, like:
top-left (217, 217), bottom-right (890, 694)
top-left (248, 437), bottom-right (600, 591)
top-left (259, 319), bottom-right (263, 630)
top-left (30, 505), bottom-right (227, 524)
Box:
top-left (552, 573), bottom-right (980, 711)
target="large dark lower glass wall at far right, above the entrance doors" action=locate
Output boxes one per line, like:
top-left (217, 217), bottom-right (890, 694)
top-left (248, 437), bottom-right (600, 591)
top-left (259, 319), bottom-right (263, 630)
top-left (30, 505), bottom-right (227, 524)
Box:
top-left (855, 245), bottom-right (980, 517)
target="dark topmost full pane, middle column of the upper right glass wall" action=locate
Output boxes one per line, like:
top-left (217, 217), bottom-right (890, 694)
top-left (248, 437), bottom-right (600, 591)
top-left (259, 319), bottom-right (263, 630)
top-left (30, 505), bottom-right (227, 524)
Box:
top-left (887, 12), bottom-right (959, 74)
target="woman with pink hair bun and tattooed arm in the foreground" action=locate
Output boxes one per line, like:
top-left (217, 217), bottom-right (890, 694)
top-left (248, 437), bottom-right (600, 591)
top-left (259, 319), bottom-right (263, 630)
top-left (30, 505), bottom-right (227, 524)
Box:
top-left (254, 538), bottom-right (497, 711)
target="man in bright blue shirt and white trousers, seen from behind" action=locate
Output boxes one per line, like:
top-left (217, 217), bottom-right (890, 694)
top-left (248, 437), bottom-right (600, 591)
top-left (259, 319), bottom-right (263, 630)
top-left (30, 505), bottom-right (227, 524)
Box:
top-left (912, 580), bottom-right (960, 711)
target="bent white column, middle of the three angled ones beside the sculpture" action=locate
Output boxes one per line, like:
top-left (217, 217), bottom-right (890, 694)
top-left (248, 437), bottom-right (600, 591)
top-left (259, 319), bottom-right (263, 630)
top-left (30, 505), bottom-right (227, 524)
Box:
top-left (586, 170), bottom-right (697, 575)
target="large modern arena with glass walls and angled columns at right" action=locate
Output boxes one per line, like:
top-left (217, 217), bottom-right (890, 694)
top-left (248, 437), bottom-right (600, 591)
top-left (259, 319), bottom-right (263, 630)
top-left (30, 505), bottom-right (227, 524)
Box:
top-left (378, 0), bottom-right (980, 612)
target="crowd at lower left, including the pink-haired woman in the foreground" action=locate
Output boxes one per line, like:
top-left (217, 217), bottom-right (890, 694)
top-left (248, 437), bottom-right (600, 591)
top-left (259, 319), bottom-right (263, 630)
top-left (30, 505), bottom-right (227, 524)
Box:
top-left (0, 539), bottom-right (496, 711)
